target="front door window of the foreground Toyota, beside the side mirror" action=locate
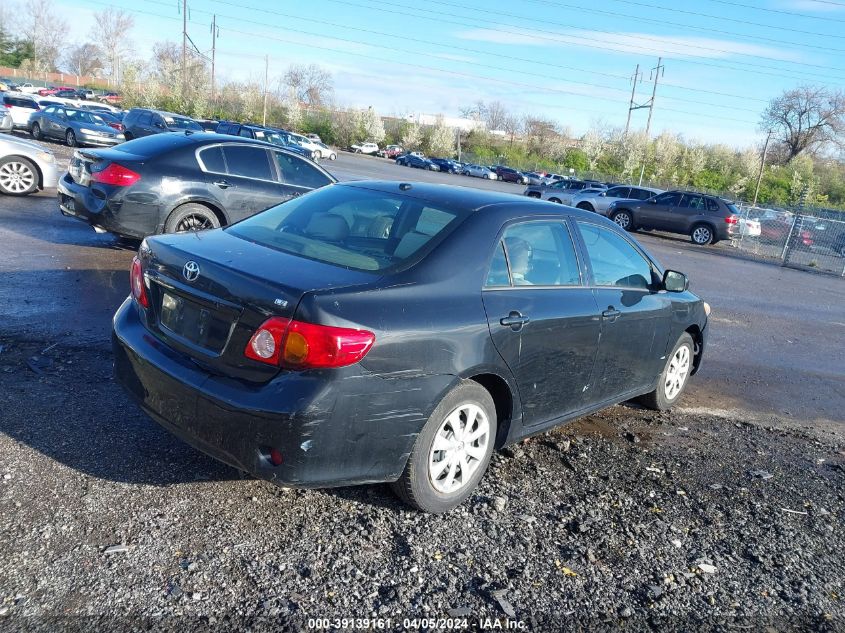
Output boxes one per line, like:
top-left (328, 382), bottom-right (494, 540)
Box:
top-left (578, 222), bottom-right (651, 289)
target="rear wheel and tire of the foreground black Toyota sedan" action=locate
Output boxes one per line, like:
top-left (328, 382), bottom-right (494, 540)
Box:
top-left (392, 380), bottom-right (497, 514)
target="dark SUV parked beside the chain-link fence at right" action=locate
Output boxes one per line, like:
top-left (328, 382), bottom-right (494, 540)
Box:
top-left (607, 191), bottom-right (739, 246)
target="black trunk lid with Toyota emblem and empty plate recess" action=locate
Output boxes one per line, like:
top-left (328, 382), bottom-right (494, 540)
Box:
top-left (142, 229), bottom-right (378, 382)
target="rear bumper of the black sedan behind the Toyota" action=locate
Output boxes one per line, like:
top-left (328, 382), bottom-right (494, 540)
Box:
top-left (57, 173), bottom-right (162, 239)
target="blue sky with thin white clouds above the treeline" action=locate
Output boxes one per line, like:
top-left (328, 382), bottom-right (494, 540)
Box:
top-left (54, 0), bottom-right (845, 147)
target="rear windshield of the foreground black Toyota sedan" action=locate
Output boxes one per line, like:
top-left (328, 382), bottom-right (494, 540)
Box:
top-left (225, 185), bottom-right (466, 271)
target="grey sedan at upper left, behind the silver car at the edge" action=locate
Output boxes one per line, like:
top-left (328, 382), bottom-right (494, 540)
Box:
top-left (29, 105), bottom-right (126, 147)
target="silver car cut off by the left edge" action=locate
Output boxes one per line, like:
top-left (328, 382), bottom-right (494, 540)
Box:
top-left (0, 134), bottom-right (59, 196)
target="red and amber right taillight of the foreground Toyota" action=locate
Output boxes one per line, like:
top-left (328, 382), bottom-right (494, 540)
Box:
top-left (244, 317), bottom-right (376, 369)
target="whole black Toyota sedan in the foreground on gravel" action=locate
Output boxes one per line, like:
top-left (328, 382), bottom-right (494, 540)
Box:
top-left (113, 182), bottom-right (709, 512)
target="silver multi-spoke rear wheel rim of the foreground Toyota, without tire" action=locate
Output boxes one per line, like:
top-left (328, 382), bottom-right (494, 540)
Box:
top-left (428, 403), bottom-right (490, 494)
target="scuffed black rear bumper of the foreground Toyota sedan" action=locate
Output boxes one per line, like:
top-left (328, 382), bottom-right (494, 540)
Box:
top-left (112, 299), bottom-right (452, 488)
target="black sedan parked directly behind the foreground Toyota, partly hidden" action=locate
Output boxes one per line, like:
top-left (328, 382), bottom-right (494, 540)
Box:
top-left (58, 133), bottom-right (335, 238)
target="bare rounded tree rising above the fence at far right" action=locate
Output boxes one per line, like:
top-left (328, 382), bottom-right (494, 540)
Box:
top-left (760, 86), bottom-right (845, 162)
